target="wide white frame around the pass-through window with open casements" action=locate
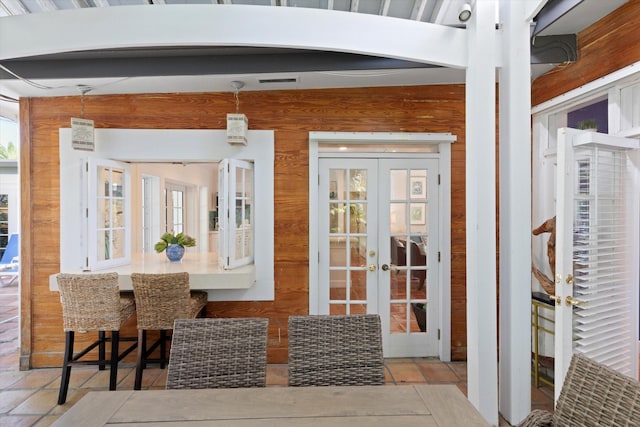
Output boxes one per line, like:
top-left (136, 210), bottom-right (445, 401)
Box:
top-left (56, 128), bottom-right (275, 301)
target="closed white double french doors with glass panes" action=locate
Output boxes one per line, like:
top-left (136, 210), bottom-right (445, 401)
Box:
top-left (318, 158), bottom-right (439, 357)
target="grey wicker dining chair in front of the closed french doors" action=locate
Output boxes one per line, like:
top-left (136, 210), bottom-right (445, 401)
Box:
top-left (288, 314), bottom-right (385, 386)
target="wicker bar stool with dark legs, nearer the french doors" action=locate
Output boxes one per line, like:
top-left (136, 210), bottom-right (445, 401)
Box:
top-left (131, 272), bottom-right (208, 390)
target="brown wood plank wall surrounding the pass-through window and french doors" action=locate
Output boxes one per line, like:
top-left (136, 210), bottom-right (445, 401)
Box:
top-left (21, 85), bottom-right (466, 367)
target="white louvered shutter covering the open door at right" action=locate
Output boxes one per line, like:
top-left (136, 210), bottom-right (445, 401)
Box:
top-left (573, 145), bottom-right (638, 377)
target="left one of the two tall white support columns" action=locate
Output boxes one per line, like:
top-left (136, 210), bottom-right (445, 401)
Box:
top-left (465, 0), bottom-right (498, 425)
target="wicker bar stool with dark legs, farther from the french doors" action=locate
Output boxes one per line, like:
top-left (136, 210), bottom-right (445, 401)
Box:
top-left (57, 273), bottom-right (136, 405)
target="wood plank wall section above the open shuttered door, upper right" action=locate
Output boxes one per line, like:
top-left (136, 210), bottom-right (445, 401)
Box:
top-left (531, 0), bottom-right (640, 105)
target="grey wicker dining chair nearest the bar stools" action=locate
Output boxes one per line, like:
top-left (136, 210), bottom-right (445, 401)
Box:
top-left (167, 318), bottom-right (269, 389)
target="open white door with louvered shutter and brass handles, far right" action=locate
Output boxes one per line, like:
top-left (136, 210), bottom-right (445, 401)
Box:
top-left (554, 128), bottom-right (638, 400)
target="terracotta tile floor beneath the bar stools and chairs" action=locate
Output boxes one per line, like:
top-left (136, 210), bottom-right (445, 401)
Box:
top-left (0, 285), bottom-right (553, 427)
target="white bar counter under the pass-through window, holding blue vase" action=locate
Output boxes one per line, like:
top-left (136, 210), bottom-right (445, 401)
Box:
top-left (49, 252), bottom-right (256, 291)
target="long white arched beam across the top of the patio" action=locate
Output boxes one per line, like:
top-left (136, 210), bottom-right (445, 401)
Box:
top-left (0, 4), bottom-right (467, 69)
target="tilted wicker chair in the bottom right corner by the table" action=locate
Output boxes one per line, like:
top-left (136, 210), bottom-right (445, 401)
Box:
top-left (518, 353), bottom-right (640, 427)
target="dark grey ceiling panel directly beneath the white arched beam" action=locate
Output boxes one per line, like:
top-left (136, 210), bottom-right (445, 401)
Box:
top-left (0, 47), bottom-right (433, 79)
